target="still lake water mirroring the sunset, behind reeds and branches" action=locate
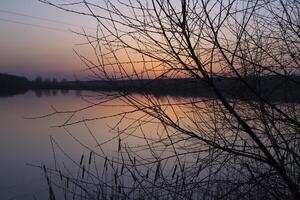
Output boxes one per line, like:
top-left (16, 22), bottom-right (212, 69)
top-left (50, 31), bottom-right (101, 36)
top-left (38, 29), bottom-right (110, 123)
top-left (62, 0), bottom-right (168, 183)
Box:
top-left (0, 91), bottom-right (298, 200)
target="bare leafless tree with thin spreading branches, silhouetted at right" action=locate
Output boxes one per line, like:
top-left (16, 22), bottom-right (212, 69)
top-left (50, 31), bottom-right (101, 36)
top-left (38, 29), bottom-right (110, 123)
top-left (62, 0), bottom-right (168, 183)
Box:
top-left (41, 0), bottom-right (300, 199)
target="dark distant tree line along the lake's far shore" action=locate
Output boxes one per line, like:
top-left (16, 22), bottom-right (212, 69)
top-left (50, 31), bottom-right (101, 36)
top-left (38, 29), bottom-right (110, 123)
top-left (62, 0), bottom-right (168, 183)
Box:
top-left (0, 74), bottom-right (300, 102)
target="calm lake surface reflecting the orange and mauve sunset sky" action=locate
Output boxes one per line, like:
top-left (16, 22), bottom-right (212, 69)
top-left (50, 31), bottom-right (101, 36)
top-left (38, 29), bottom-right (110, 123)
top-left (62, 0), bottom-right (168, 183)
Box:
top-left (0, 90), bottom-right (299, 199)
